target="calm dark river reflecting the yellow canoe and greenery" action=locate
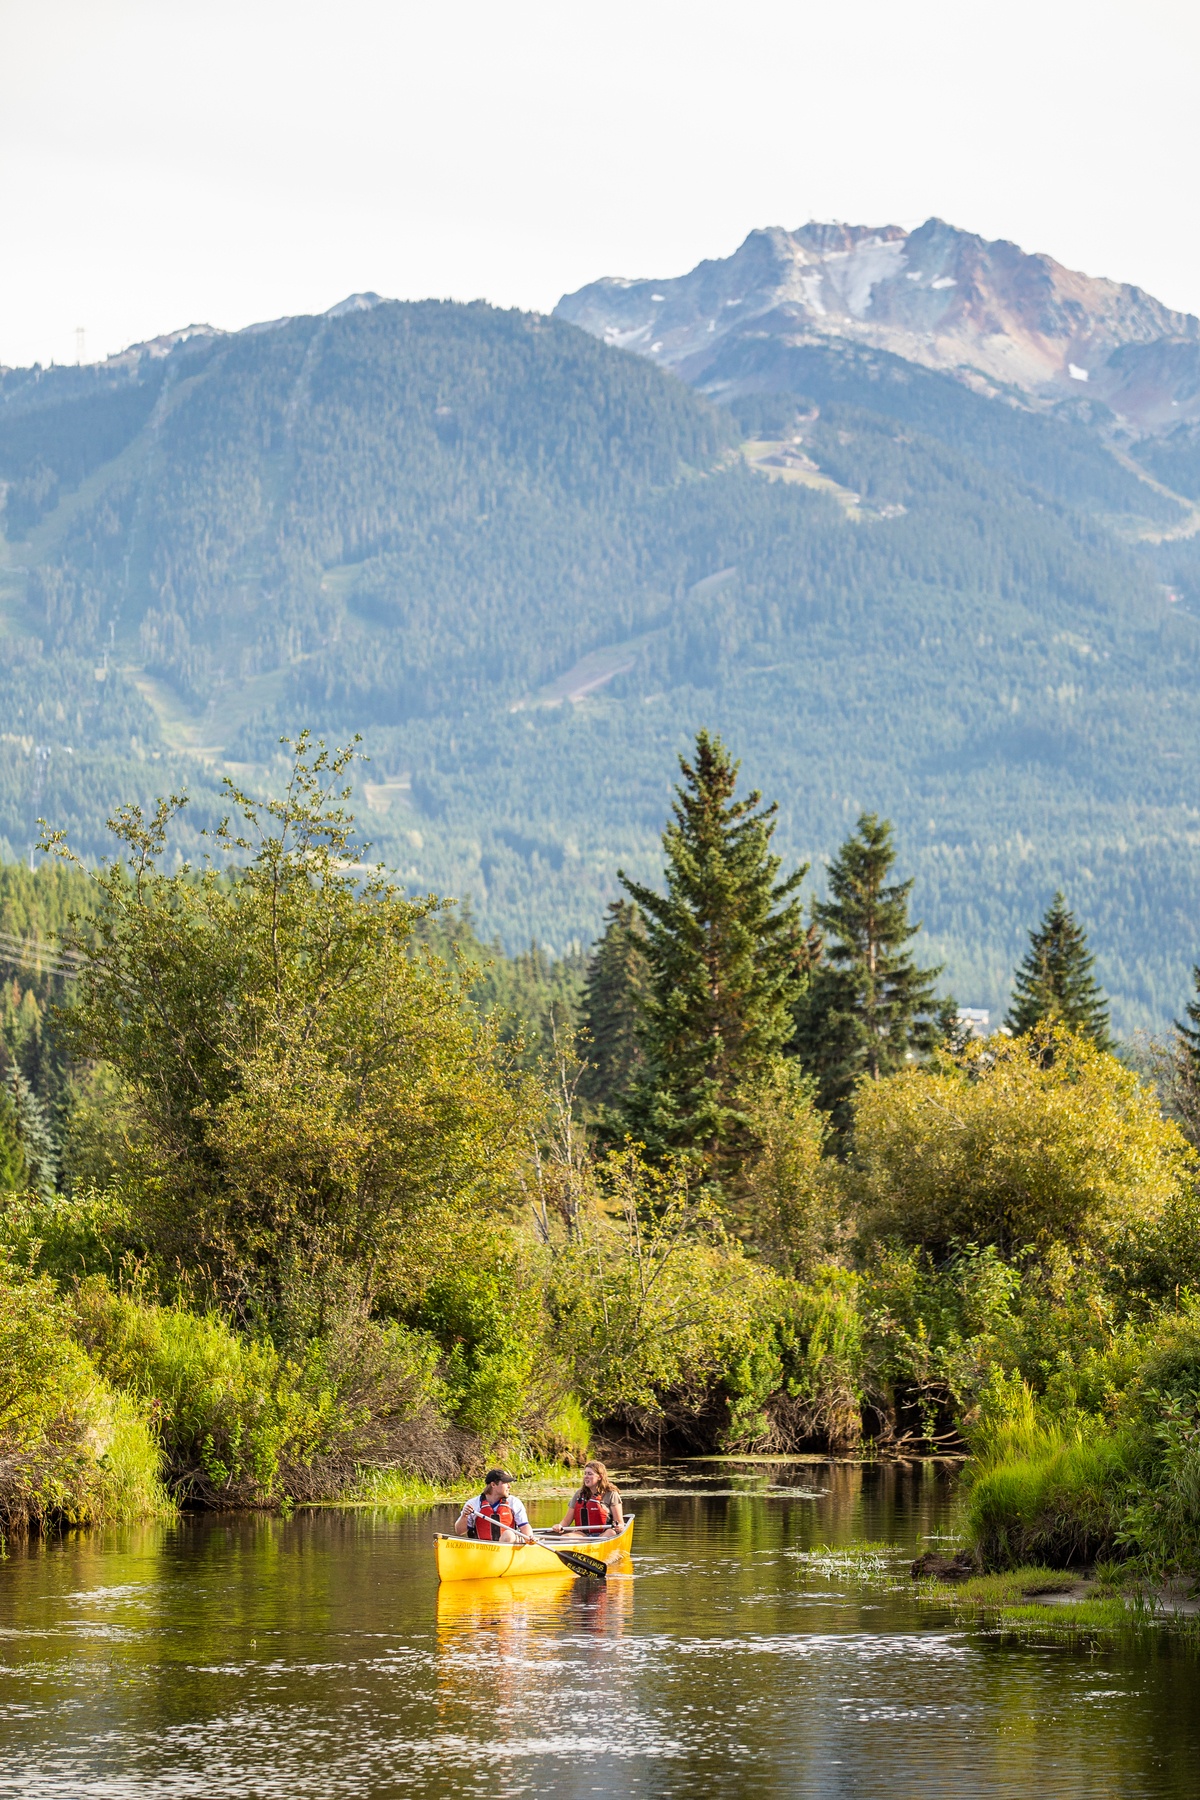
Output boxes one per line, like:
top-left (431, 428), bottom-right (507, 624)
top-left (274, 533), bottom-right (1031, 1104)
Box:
top-left (0, 1463), bottom-right (1200, 1800)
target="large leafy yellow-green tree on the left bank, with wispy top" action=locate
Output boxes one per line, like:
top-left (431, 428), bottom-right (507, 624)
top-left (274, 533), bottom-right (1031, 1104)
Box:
top-left (48, 738), bottom-right (527, 1312)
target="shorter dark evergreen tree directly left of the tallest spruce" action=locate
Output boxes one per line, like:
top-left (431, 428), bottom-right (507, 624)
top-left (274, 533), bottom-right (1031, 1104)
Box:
top-left (579, 900), bottom-right (649, 1114)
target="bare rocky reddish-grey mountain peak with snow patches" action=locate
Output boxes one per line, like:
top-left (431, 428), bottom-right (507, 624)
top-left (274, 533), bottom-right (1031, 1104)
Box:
top-left (554, 218), bottom-right (1200, 434)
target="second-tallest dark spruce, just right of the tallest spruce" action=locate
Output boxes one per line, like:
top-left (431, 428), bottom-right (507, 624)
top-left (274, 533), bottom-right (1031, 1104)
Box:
top-left (790, 812), bottom-right (955, 1132)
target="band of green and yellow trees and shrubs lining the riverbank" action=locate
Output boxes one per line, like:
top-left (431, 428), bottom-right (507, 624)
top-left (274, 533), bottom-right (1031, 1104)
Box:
top-left (0, 733), bottom-right (1200, 1573)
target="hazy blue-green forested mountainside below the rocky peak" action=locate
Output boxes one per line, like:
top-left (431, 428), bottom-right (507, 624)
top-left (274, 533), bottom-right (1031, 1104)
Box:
top-left (0, 289), bottom-right (1200, 1030)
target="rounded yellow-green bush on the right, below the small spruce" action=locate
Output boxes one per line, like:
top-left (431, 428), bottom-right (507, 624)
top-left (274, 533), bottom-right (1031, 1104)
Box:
top-left (855, 1028), bottom-right (1195, 1249)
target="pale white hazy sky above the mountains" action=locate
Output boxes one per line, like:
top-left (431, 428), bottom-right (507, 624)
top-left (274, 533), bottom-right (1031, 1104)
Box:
top-left (0, 0), bottom-right (1200, 364)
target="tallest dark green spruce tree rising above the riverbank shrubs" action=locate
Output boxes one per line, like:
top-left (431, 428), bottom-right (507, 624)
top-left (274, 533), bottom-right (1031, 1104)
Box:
top-left (621, 731), bottom-right (808, 1179)
